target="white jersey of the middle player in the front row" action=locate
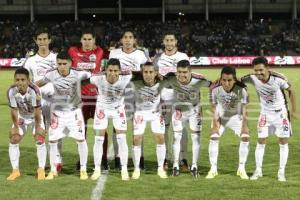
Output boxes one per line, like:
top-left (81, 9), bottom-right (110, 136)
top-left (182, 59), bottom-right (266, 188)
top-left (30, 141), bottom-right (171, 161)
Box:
top-left (132, 75), bottom-right (163, 112)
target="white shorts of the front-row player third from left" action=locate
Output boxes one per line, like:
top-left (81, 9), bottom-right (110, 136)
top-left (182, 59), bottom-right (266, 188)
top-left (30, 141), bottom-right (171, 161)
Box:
top-left (94, 104), bottom-right (127, 131)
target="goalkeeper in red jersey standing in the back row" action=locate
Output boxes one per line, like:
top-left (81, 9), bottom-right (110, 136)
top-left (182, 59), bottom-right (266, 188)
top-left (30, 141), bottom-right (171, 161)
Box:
top-left (68, 29), bottom-right (108, 170)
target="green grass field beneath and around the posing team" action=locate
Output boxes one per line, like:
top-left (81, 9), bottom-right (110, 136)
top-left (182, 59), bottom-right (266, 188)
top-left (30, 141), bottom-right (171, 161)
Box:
top-left (0, 68), bottom-right (300, 200)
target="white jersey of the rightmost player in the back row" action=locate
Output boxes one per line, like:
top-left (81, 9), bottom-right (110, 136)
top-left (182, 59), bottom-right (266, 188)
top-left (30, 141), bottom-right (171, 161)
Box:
top-left (156, 51), bottom-right (189, 76)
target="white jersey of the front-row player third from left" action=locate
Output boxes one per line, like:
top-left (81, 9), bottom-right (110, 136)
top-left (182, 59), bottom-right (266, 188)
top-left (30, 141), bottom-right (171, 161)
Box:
top-left (90, 74), bottom-right (132, 110)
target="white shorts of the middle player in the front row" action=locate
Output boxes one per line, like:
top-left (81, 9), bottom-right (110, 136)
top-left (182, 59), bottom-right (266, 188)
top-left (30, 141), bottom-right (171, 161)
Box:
top-left (133, 111), bottom-right (165, 135)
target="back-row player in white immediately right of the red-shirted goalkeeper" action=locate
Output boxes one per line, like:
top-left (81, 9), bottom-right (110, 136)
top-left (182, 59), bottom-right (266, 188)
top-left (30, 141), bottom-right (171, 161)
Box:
top-left (109, 30), bottom-right (147, 169)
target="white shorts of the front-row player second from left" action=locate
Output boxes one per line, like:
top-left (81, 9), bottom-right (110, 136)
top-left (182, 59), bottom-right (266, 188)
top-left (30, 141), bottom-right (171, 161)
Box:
top-left (49, 108), bottom-right (85, 141)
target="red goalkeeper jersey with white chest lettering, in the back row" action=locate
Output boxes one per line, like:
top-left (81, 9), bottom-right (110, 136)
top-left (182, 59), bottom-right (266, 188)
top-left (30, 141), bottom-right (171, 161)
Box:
top-left (68, 47), bottom-right (103, 98)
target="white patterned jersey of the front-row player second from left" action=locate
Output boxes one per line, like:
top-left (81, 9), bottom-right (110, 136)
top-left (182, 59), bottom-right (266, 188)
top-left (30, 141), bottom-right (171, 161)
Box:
top-left (43, 69), bottom-right (91, 111)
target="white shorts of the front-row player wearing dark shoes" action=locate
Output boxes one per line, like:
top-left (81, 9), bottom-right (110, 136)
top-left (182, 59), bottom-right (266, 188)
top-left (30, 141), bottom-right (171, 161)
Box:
top-left (172, 106), bottom-right (202, 132)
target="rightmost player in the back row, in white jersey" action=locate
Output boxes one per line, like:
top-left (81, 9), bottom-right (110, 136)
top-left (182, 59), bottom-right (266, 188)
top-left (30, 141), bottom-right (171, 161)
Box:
top-left (154, 32), bottom-right (189, 171)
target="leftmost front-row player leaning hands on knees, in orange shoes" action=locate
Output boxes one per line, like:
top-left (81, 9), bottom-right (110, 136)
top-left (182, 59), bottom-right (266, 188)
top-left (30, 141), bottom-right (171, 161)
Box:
top-left (7, 68), bottom-right (47, 181)
